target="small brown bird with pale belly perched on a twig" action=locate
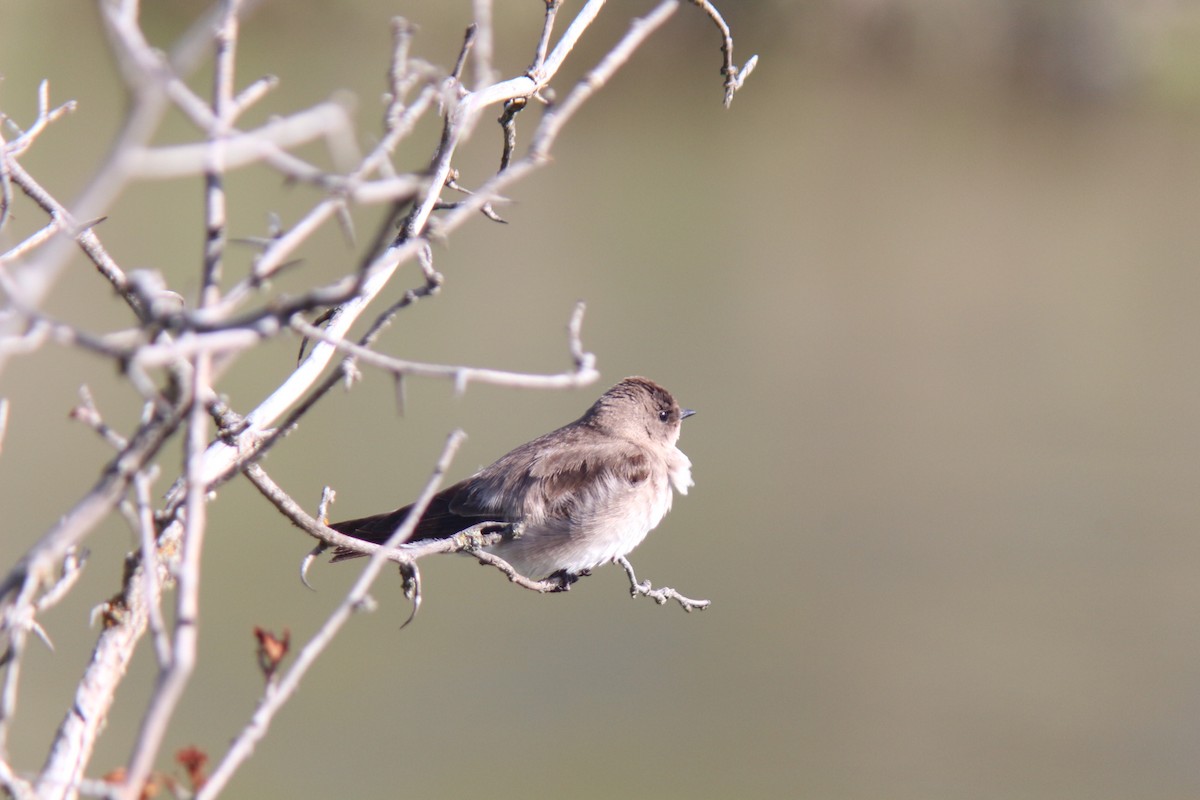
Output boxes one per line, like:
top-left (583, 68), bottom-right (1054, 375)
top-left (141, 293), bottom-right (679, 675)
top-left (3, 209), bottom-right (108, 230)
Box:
top-left (330, 375), bottom-right (695, 585)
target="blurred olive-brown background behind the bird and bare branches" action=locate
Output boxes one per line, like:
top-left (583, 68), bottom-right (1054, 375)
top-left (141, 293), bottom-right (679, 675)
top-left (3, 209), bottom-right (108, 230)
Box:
top-left (0, 0), bottom-right (1200, 800)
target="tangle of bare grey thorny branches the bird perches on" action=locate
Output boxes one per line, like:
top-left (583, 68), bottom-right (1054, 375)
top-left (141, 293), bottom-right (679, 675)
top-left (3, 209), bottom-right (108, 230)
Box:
top-left (0, 0), bottom-right (756, 800)
